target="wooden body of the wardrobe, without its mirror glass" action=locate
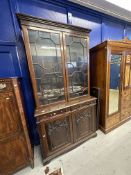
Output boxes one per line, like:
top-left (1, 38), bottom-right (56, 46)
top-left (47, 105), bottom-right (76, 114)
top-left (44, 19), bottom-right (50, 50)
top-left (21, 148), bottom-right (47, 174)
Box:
top-left (90, 39), bottom-right (131, 133)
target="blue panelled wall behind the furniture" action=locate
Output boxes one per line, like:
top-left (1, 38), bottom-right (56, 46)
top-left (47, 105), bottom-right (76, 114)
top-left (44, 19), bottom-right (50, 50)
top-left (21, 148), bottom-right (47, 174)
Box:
top-left (0, 0), bottom-right (131, 144)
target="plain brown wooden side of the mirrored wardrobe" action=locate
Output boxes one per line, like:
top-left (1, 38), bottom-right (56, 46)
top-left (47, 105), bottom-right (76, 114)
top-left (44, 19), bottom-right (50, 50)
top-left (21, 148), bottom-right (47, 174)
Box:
top-left (90, 46), bottom-right (107, 128)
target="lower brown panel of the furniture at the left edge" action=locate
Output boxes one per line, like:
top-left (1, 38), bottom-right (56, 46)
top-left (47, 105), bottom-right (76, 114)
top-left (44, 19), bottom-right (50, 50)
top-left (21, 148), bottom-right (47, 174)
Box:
top-left (0, 136), bottom-right (29, 175)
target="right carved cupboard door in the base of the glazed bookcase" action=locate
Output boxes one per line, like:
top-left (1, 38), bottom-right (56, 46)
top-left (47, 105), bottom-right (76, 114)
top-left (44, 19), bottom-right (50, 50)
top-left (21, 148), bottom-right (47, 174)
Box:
top-left (72, 106), bottom-right (96, 142)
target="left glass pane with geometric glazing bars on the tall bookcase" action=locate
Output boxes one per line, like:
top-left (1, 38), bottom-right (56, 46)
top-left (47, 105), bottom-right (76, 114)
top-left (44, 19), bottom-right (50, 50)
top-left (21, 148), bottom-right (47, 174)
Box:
top-left (29, 30), bottom-right (64, 105)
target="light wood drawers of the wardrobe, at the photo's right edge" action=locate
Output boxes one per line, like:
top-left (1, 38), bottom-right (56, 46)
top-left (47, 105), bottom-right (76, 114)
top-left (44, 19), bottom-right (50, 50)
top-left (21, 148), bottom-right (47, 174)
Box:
top-left (121, 88), bottom-right (131, 120)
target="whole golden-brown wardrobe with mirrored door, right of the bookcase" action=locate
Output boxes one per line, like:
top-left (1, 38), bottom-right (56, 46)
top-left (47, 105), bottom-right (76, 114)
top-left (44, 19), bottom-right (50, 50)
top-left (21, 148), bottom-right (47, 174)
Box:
top-left (90, 38), bottom-right (131, 133)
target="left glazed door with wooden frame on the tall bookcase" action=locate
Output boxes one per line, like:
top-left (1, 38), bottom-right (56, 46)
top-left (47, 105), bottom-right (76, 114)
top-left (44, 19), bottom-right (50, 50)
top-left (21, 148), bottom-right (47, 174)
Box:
top-left (24, 28), bottom-right (66, 107)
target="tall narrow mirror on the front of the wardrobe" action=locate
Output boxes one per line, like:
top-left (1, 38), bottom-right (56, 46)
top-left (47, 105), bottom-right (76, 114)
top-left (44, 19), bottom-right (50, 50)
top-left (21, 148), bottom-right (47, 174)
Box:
top-left (109, 54), bottom-right (121, 115)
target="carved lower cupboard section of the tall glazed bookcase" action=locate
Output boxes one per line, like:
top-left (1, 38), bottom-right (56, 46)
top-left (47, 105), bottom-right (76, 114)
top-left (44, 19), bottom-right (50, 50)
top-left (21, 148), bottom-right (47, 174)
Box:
top-left (36, 98), bottom-right (96, 164)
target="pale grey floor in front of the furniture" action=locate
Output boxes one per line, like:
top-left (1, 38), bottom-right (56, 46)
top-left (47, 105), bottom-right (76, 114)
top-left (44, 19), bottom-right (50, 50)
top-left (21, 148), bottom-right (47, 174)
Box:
top-left (15, 121), bottom-right (131, 175)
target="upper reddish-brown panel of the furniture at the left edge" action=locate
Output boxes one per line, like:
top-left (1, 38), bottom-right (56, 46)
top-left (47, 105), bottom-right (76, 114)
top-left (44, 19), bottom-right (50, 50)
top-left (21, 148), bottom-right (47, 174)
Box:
top-left (0, 92), bottom-right (21, 138)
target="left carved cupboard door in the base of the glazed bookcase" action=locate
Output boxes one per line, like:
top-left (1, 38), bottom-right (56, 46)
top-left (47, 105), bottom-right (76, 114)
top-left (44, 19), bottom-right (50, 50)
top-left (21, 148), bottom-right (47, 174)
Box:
top-left (40, 114), bottom-right (72, 155)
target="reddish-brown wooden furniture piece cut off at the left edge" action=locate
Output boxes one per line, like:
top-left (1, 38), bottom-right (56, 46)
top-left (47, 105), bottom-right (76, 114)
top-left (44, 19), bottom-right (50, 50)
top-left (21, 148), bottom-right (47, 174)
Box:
top-left (0, 78), bottom-right (33, 175)
